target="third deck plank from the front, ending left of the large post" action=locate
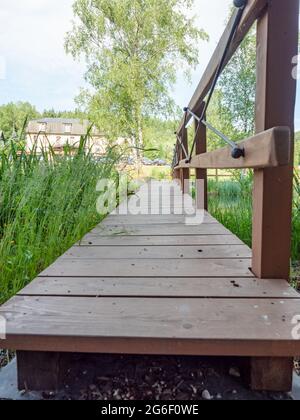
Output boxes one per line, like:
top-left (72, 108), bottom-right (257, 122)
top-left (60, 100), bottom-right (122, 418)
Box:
top-left (41, 259), bottom-right (253, 278)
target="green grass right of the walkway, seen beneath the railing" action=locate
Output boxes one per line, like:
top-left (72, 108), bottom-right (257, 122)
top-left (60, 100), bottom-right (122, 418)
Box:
top-left (208, 172), bottom-right (300, 268)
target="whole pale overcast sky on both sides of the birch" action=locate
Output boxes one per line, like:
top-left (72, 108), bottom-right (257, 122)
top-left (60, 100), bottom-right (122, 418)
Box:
top-left (0, 0), bottom-right (300, 129)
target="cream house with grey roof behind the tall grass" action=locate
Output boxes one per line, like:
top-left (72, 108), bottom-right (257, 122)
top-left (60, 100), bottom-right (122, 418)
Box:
top-left (26, 118), bottom-right (107, 156)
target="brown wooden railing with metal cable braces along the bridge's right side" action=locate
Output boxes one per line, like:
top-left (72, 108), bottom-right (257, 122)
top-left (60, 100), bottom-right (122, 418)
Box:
top-left (173, 0), bottom-right (299, 279)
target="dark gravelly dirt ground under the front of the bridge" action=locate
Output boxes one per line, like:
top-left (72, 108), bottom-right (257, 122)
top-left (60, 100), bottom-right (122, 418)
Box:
top-left (12, 355), bottom-right (291, 401)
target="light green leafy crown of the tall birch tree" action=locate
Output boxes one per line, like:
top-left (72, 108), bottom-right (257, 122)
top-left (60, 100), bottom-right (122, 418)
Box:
top-left (66, 0), bottom-right (206, 156)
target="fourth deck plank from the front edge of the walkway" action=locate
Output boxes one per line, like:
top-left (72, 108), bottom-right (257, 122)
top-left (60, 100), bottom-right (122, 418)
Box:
top-left (60, 245), bottom-right (252, 260)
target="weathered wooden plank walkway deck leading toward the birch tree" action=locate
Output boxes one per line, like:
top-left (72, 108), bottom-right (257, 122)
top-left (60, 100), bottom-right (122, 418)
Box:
top-left (0, 180), bottom-right (300, 368)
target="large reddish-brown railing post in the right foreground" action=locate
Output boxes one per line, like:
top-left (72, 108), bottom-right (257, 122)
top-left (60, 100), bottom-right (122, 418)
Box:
top-left (252, 0), bottom-right (299, 279)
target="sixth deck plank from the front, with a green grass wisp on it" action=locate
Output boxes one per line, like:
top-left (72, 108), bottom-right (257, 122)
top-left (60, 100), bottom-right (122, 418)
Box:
top-left (89, 223), bottom-right (231, 236)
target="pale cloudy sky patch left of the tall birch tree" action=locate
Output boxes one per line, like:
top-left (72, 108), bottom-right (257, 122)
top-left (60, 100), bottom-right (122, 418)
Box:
top-left (0, 0), bottom-right (85, 109)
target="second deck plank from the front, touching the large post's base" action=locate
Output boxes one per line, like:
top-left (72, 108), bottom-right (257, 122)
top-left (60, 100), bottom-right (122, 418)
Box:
top-left (19, 277), bottom-right (299, 299)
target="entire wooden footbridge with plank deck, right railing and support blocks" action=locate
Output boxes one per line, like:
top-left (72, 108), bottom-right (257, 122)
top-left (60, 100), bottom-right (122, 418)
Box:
top-left (0, 0), bottom-right (300, 391)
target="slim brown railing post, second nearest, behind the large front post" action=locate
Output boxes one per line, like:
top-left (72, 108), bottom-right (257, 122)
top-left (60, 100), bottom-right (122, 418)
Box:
top-left (195, 103), bottom-right (208, 210)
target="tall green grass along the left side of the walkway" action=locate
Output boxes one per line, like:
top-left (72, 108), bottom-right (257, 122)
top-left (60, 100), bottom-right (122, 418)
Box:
top-left (0, 138), bottom-right (117, 302)
